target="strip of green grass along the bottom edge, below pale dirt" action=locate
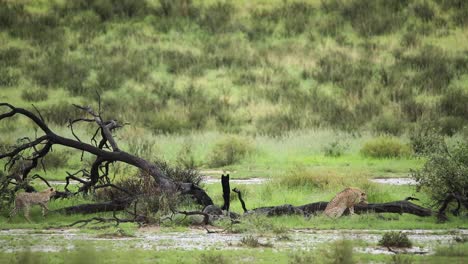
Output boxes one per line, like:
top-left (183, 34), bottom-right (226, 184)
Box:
top-left (0, 241), bottom-right (466, 264)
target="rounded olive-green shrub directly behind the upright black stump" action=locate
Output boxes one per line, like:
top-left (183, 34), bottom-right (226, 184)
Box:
top-left (210, 135), bottom-right (254, 167)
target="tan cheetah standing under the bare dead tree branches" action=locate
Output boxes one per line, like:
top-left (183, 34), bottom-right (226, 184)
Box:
top-left (10, 188), bottom-right (55, 222)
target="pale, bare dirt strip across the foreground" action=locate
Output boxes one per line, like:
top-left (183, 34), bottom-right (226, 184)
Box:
top-left (0, 228), bottom-right (468, 254)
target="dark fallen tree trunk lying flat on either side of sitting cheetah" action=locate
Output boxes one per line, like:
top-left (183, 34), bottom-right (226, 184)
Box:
top-left (249, 200), bottom-right (432, 217)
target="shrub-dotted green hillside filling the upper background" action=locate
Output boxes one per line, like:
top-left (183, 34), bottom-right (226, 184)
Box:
top-left (0, 0), bottom-right (468, 135)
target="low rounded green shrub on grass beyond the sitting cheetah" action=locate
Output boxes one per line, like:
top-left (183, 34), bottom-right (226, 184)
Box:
top-left (361, 136), bottom-right (411, 158)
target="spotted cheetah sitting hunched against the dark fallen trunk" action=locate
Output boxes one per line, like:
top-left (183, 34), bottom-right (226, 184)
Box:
top-left (324, 188), bottom-right (367, 218)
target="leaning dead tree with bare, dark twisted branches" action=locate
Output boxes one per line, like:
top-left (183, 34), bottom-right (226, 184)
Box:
top-left (0, 102), bottom-right (213, 213)
